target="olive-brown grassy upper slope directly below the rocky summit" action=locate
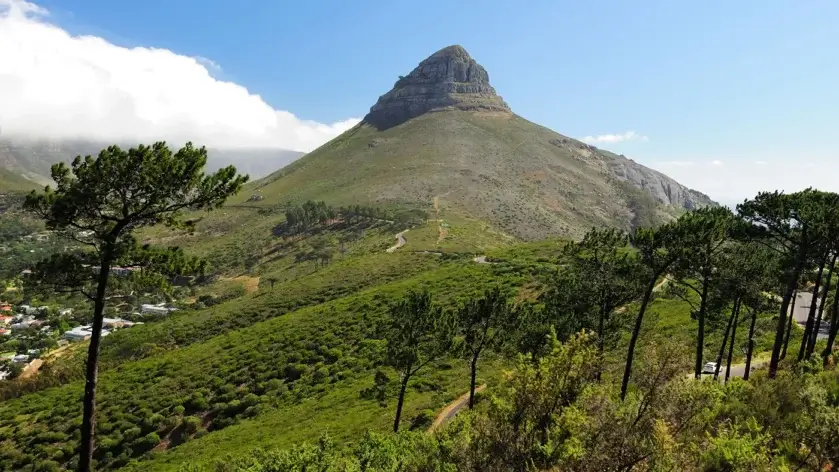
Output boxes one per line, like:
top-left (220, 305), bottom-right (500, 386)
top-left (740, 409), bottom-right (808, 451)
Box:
top-left (220, 111), bottom-right (712, 239)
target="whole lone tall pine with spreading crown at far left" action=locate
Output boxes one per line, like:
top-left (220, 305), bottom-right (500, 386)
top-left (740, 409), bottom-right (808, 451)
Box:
top-left (24, 142), bottom-right (248, 471)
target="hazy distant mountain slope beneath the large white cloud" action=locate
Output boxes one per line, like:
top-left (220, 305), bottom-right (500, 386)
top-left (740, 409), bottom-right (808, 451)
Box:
top-left (0, 137), bottom-right (303, 181)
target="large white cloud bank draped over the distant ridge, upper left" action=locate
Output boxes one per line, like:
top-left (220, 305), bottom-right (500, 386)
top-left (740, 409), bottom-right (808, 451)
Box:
top-left (0, 0), bottom-right (359, 151)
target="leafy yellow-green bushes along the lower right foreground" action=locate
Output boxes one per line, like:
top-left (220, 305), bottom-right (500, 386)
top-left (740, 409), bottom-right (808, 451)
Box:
top-left (180, 342), bottom-right (839, 472)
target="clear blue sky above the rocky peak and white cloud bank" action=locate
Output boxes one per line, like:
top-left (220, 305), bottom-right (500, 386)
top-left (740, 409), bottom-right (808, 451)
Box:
top-left (0, 0), bottom-right (839, 201)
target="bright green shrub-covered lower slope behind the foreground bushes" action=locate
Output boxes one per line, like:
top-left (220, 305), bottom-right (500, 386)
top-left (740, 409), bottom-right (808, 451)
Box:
top-left (0, 232), bottom-right (771, 470)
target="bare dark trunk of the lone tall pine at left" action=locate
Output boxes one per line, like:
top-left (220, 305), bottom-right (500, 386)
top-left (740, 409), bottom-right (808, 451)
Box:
top-left (78, 256), bottom-right (112, 472)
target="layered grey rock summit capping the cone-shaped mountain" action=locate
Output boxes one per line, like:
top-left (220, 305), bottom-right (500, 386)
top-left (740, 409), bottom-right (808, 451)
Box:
top-left (364, 46), bottom-right (512, 130)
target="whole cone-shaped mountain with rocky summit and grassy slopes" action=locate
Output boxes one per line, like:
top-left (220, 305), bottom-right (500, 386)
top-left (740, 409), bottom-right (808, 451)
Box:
top-left (249, 46), bottom-right (715, 239)
